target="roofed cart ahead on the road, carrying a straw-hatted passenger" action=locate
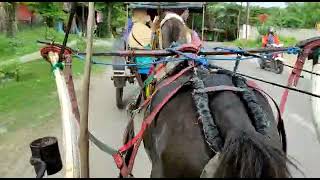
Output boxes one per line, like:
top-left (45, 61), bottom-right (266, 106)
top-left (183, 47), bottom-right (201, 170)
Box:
top-left (111, 2), bottom-right (205, 109)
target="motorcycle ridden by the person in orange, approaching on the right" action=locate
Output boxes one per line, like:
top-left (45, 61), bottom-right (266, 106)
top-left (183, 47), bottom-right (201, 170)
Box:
top-left (259, 44), bottom-right (284, 74)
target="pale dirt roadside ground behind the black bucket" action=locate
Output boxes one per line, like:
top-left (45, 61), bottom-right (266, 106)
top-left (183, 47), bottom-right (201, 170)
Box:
top-left (0, 111), bottom-right (62, 177)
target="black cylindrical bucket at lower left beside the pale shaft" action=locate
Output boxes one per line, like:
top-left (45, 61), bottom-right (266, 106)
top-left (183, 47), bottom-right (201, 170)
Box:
top-left (30, 137), bottom-right (62, 175)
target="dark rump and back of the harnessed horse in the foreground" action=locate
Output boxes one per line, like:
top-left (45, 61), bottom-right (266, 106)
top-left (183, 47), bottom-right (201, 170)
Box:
top-left (144, 64), bottom-right (287, 177)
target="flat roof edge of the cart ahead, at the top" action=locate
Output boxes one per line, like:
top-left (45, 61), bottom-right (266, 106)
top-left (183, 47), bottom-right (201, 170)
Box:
top-left (126, 2), bottom-right (206, 12)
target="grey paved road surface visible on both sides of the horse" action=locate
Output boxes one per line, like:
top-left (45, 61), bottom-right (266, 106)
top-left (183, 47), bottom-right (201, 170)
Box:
top-left (8, 41), bottom-right (320, 177)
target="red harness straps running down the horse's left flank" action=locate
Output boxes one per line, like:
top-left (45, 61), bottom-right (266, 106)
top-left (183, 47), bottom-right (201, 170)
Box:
top-left (113, 66), bottom-right (194, 177)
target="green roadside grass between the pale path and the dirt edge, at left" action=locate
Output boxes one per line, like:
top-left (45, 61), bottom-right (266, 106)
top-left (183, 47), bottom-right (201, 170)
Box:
top-left (0, 55), bottom-right (110, 134)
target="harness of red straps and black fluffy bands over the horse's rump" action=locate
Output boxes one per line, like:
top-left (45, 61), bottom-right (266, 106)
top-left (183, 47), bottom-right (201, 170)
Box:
top-left (113, 54), bottom-right (287, 177)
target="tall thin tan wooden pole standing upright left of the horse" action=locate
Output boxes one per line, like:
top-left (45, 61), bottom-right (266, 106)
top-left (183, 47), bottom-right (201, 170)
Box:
top-left (79, 2), bottom-right (94, 178)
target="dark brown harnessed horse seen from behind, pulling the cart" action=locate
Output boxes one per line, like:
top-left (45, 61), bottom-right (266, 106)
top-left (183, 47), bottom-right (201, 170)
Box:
top-left (125, 13), bottom-right (296, 178)
